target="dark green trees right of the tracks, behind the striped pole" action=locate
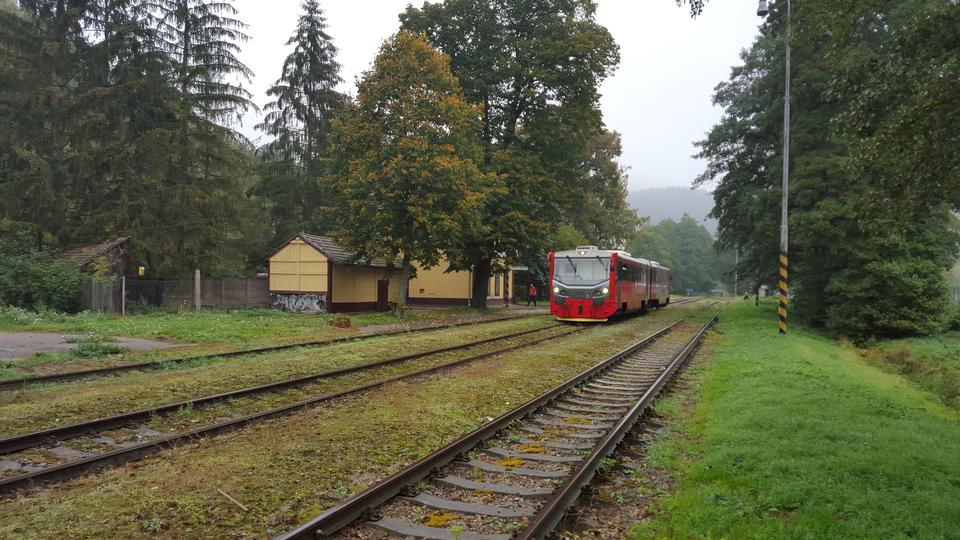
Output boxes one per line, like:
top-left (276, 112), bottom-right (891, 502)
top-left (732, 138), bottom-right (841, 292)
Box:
top-left (697, 0), bottom-right (960, 340)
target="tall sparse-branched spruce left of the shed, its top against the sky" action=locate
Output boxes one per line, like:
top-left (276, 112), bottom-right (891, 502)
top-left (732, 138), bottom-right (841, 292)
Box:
top-left (139, 0), bottom-right (255, 275)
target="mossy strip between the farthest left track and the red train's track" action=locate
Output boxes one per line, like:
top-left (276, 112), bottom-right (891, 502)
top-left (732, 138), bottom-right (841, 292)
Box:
top-left (0, 317), bottom-right (554, 435)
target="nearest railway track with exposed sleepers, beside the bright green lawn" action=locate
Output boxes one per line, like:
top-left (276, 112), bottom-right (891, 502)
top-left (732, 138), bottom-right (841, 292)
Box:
top-left (278, 315), bottom-right (718, 540)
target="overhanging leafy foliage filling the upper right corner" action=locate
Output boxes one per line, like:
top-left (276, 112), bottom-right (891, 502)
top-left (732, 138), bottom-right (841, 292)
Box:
top-left (797, 0), bottom-right (960, 215)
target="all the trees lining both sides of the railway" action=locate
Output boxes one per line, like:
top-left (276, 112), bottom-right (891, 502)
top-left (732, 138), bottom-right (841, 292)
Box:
top-left (0, 0), bottom-right (960, 339)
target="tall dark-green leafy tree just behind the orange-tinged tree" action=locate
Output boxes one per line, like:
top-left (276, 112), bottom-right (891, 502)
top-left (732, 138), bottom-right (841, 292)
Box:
top-left (400, 0), bottom-right (619, 307)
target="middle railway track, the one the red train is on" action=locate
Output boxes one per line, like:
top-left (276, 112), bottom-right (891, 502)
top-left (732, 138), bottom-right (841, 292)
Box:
top-left (0, 324), bottom-right (585, 495)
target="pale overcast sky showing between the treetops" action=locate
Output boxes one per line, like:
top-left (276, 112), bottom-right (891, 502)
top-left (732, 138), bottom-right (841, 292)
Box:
top-left (234, 0), bottom-right (760, 189)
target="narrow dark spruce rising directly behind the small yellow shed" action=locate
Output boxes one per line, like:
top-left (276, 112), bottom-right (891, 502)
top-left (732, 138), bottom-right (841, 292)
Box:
top-left (257, 0), bottom-right (345, 238)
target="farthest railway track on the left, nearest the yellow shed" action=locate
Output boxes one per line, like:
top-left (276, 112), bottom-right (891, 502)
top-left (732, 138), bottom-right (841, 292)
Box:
top-left (0, 314), bottom-right (539, 391)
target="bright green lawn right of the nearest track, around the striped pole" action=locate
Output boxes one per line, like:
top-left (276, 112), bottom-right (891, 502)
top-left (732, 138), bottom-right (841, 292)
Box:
top-left (631, 303), bottom-right (960, 538)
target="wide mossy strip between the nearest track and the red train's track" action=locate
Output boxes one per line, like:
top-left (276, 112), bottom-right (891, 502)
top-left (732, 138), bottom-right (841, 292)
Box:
top-left (0, 306), bottom-right (708, 538)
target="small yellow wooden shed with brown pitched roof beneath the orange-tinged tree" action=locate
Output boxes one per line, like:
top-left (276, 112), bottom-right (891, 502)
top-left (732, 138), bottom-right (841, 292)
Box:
top-left (269, 233), bottom-right (400, 312)
